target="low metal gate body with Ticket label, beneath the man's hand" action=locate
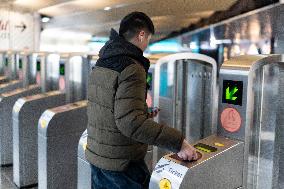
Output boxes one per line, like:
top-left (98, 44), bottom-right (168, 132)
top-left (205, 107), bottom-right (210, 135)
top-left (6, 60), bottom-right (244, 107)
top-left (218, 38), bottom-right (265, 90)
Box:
top-left (149, 135), bottom-right (244, 189)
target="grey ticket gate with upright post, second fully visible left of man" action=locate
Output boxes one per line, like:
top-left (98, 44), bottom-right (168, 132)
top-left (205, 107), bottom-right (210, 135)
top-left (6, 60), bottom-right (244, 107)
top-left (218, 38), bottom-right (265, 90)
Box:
top-left (13, 53), bottom-right (68, 187)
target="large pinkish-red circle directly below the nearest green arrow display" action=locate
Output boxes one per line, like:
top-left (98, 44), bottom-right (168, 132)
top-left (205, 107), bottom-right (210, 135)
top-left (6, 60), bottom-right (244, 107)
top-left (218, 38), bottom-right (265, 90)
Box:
top-left (221, 108), bottom-right (242, 133)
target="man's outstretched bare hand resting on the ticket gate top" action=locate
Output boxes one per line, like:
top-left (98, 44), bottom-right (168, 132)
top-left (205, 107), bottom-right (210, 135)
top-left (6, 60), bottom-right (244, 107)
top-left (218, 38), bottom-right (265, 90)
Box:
top-left (177, 140), bottom-right (198, 161)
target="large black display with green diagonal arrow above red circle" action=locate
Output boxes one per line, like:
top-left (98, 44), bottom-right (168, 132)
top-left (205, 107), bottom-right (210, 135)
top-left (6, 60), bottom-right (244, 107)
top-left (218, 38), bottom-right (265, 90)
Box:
top-left (222, 80), bottom-right (243, 106)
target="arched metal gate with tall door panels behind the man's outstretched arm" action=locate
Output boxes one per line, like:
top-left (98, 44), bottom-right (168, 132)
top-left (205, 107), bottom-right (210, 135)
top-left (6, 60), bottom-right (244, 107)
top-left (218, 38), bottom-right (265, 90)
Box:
top-left (153, 53), bottom-right (217, 166)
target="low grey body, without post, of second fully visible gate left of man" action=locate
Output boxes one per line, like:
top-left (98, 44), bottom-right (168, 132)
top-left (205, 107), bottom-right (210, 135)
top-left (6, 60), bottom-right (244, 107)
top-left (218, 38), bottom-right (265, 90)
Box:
top-left (13, 91), bottom-right (66, 187)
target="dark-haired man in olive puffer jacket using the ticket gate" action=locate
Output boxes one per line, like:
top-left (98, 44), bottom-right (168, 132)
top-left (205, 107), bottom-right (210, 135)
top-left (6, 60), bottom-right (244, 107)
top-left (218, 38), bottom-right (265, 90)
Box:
top-left (86, 12), bottom-right (197, 189)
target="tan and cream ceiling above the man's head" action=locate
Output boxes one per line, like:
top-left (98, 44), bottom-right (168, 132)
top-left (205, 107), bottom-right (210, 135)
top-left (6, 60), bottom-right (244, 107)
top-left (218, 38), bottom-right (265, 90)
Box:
top-left (10, 0), bottom-right (237, 38)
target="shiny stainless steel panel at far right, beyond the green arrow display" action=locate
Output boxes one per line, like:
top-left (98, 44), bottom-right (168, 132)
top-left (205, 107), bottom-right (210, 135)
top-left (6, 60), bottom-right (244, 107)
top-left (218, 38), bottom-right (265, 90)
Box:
top-left (245, 63), bottom-right (284, 189)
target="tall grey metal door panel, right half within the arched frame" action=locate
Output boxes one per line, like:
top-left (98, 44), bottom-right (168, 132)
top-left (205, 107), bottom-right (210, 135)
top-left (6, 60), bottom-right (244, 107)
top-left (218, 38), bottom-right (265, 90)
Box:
top-left (183, 60), bottom-right (214, 142)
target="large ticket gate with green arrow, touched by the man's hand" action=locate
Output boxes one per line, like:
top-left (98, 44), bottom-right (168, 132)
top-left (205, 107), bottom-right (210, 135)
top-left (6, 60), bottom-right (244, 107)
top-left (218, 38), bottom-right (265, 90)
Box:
top-left (149, 55), bottom-right (284, 189)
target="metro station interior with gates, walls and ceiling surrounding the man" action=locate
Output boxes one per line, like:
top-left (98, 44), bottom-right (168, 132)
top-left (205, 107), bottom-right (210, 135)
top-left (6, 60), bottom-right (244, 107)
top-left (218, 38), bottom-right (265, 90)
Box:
top-left (0, 0), bottom-right (284, 189)
